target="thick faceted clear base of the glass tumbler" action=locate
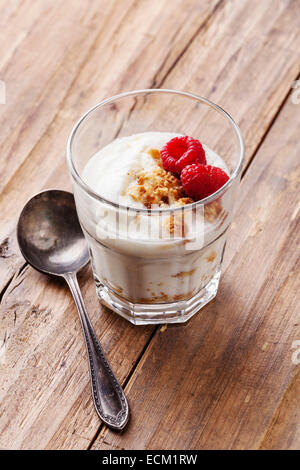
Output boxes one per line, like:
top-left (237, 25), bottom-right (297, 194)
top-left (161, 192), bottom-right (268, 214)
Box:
top-left (95, 271), bottom-right (220, 325)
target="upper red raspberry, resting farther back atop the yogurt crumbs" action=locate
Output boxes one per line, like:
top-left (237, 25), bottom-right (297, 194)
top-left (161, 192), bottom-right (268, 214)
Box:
top-left (160, 135), bottom-right (206, 175)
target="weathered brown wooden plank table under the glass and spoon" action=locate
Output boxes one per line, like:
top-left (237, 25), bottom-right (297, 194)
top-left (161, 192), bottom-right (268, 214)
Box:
top-left (0, 0), bottom-right (300, 450)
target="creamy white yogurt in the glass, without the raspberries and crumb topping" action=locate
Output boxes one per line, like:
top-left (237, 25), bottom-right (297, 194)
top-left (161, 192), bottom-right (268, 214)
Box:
top-left (77, 132), bottom-right (228, 303)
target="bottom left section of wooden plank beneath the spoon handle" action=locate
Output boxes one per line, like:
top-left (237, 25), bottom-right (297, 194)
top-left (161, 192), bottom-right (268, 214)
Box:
top-left (0, 260), bottom-right (152, 449)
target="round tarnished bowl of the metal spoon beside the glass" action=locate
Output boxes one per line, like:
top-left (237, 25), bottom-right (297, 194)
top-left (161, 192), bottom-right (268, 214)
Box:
top-left (17, 190), bottom-right (89, 276)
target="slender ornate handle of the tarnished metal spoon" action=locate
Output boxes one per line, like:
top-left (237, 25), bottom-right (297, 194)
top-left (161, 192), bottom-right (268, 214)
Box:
top-left (64, 273), bottom-right (129, 430)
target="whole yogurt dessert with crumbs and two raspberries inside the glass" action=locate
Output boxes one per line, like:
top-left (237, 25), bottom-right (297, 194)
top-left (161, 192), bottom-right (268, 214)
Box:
top-left (77, 132), bottom-right (229, 313)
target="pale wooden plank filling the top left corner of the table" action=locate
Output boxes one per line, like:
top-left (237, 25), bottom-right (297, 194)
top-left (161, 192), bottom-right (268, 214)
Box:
top-left (0, 0), bottom-right (126, 188)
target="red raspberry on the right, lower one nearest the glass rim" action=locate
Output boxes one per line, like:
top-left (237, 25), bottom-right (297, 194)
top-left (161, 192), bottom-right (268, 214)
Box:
top-left (180, 163), bottom-right (229, 201)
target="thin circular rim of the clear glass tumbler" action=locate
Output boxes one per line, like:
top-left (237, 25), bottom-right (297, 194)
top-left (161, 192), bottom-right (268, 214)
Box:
top-left (67, 88), bottom-right (245, 214)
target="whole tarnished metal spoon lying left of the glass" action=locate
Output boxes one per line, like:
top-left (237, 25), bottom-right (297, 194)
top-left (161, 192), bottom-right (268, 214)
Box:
top-left (17, 190), bottom-right (129, 430)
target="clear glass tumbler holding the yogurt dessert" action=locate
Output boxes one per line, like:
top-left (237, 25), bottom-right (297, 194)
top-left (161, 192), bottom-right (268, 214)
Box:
top-left (67, 89), bottom-right (244, 324)
